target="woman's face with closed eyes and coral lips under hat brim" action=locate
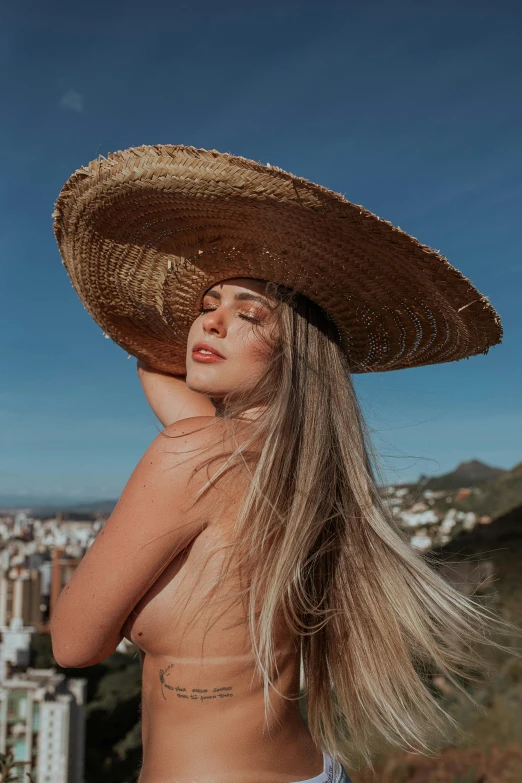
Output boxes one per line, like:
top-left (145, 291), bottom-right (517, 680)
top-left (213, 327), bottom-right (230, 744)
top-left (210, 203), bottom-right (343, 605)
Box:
top-left (186, 277), bottom-right (277, 399)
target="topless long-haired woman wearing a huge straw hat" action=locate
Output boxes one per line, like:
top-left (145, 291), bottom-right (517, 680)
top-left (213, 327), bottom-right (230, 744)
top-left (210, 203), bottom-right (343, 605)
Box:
top-left (51, 145), bottom-right (505, 783)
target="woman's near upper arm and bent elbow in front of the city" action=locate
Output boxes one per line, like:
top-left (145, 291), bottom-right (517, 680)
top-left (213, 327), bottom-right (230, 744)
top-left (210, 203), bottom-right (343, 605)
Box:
top-left (50, 417), bottom-right (219, 669)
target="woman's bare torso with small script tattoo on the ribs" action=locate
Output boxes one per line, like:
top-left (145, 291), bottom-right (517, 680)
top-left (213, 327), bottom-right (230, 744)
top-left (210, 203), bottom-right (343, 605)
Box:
top-left (123, 426), bottom-right (323, 783)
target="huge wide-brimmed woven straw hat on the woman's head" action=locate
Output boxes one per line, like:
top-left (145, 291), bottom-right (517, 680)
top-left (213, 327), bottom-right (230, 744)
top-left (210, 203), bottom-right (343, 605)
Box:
top-left (53, 144), bottom-right (502, 373)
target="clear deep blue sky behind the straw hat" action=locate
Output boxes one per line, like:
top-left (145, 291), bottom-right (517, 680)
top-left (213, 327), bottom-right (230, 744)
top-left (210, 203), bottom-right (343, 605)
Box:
top-left (0, 0), bottom-right (522, 501)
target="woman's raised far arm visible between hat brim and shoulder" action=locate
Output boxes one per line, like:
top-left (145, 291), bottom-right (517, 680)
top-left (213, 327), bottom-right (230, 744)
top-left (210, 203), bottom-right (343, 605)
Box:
top-left (136, 359), bottom-right (216, 427)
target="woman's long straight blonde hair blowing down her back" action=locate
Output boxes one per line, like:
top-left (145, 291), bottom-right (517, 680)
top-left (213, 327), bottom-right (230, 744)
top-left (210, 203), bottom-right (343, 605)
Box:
top-left (162, 284), bottom-right (513, 766)
